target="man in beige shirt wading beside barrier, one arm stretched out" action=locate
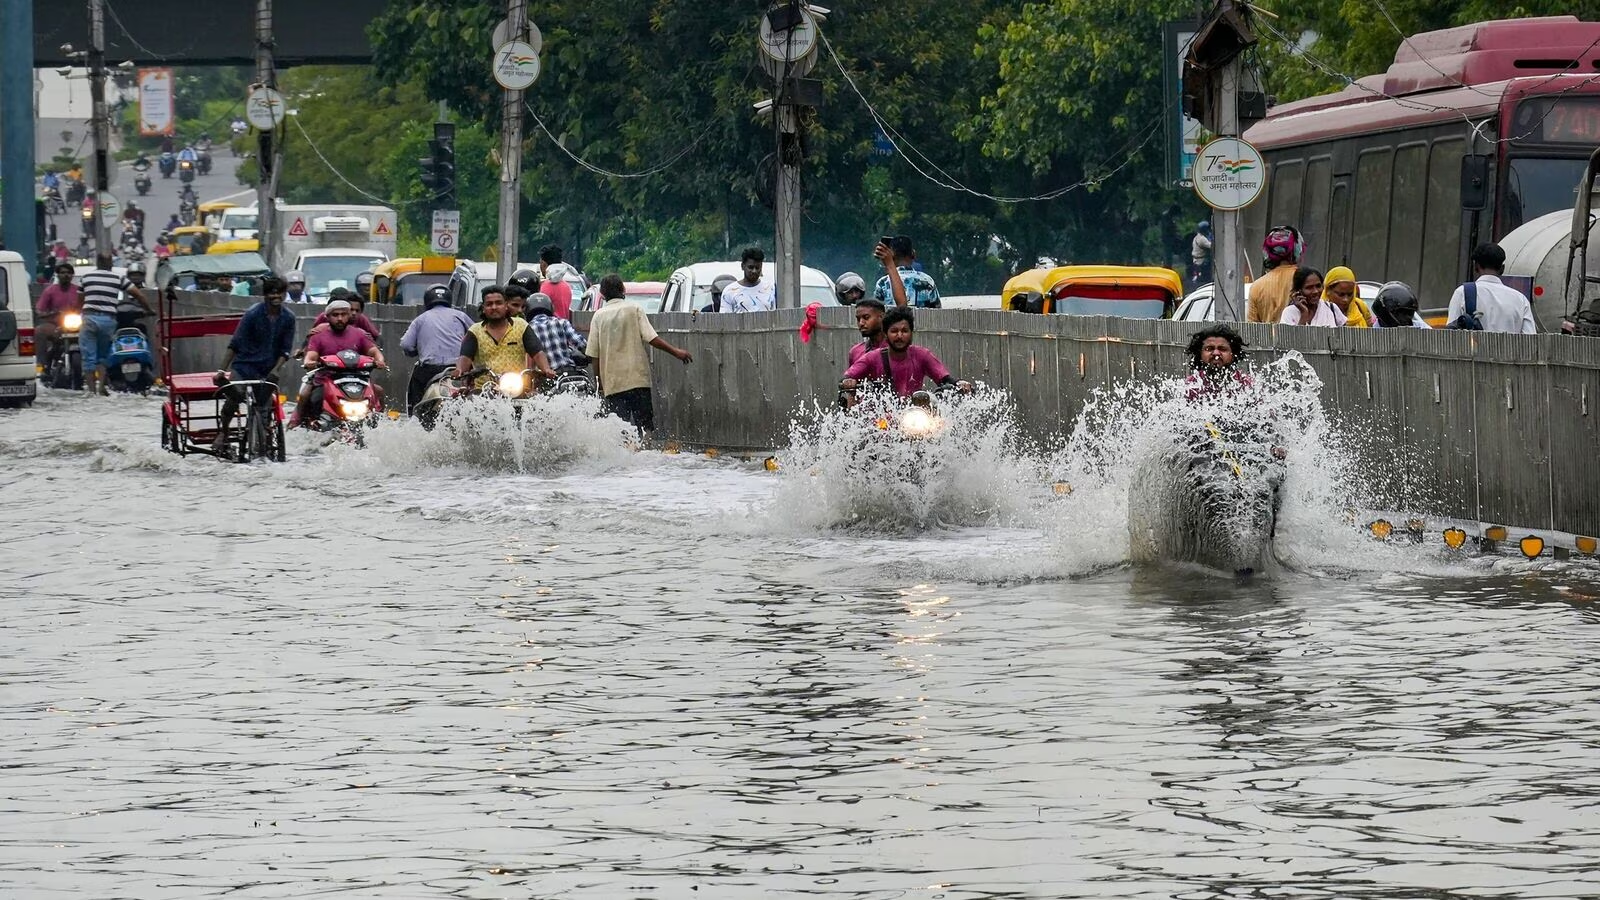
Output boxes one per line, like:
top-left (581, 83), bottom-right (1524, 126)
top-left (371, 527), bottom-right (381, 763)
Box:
top-left (587, 274), bottom-right (694, 432)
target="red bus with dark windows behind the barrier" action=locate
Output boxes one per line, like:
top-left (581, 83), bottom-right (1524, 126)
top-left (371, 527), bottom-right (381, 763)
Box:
top-left (1245, 16), bottom-right (1600, 319)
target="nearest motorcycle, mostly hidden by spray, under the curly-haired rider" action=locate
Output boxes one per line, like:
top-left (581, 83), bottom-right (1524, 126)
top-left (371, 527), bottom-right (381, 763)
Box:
top-left (1128, 423), bottom-right (1285, 575)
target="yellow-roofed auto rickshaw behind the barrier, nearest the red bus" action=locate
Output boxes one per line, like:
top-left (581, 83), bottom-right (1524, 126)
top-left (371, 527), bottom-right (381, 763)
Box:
top-left (1000, 266), bottom-right (1184, 319)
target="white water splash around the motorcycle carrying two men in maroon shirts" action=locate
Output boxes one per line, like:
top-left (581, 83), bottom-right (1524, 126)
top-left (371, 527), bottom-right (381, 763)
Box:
top-left (770, 391), bottom-right (1043, 532)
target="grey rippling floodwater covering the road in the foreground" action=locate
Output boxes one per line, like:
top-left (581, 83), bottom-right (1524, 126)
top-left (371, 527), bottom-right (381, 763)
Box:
top-left (0, 379), bottom-right (1600, 900)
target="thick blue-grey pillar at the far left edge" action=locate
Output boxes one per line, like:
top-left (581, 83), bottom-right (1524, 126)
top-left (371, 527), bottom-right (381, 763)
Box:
top-left (0, 2), bottom-right (38, 271)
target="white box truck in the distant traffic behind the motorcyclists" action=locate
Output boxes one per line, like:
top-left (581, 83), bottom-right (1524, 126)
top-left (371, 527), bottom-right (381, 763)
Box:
top-left (270, 200), bottom-right (398, 301)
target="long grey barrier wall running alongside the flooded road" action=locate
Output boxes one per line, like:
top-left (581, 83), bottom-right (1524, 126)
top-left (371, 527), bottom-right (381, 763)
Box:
top-left (176, 295), bottom-right (1600, 535)
